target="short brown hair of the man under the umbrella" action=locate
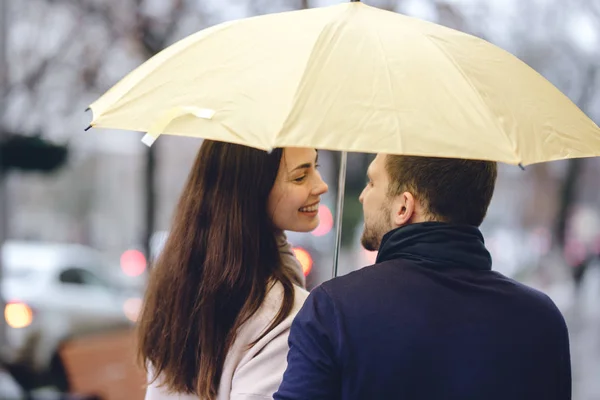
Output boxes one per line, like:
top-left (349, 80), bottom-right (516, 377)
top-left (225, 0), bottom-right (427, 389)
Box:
top-left (385, 155), bottom-right (498, 226)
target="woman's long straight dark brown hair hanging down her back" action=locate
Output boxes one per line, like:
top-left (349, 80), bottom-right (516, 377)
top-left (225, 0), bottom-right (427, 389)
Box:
top-left (138, 140), bottom-right (294, 399)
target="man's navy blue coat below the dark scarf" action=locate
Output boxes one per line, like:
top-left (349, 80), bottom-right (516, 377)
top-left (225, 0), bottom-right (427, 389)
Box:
top-left (275, 223), bottom-right (571, 400)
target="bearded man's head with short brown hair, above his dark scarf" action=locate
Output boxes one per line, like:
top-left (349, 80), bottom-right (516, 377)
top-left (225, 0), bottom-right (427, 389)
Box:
top-left (359, 154), bottom-right (497, 250)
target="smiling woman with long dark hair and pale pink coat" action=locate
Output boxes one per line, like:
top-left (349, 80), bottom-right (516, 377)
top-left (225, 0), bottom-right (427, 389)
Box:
top-left (138, 140), bottom-right (327, 400)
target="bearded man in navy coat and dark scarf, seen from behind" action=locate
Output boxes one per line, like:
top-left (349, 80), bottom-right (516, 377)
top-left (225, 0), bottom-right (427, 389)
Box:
top-left (274, 154), bottom-right (571, 400)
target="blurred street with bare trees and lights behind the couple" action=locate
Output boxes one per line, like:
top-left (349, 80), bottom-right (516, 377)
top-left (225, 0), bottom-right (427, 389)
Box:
top-left (0, 0), bottom-right (600, 400)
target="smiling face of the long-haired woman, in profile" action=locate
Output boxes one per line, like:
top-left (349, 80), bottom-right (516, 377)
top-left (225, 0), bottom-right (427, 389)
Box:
top-left (267, 147), bottom-right (328, 232)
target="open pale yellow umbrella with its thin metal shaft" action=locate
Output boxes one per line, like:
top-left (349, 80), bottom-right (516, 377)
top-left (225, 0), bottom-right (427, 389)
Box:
top-left (90, 1), bottom-right (600, 275)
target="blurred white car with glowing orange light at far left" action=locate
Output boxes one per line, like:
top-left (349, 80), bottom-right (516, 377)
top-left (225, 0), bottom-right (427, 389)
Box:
top-left (1, 241), bottom-right (138, 391)
